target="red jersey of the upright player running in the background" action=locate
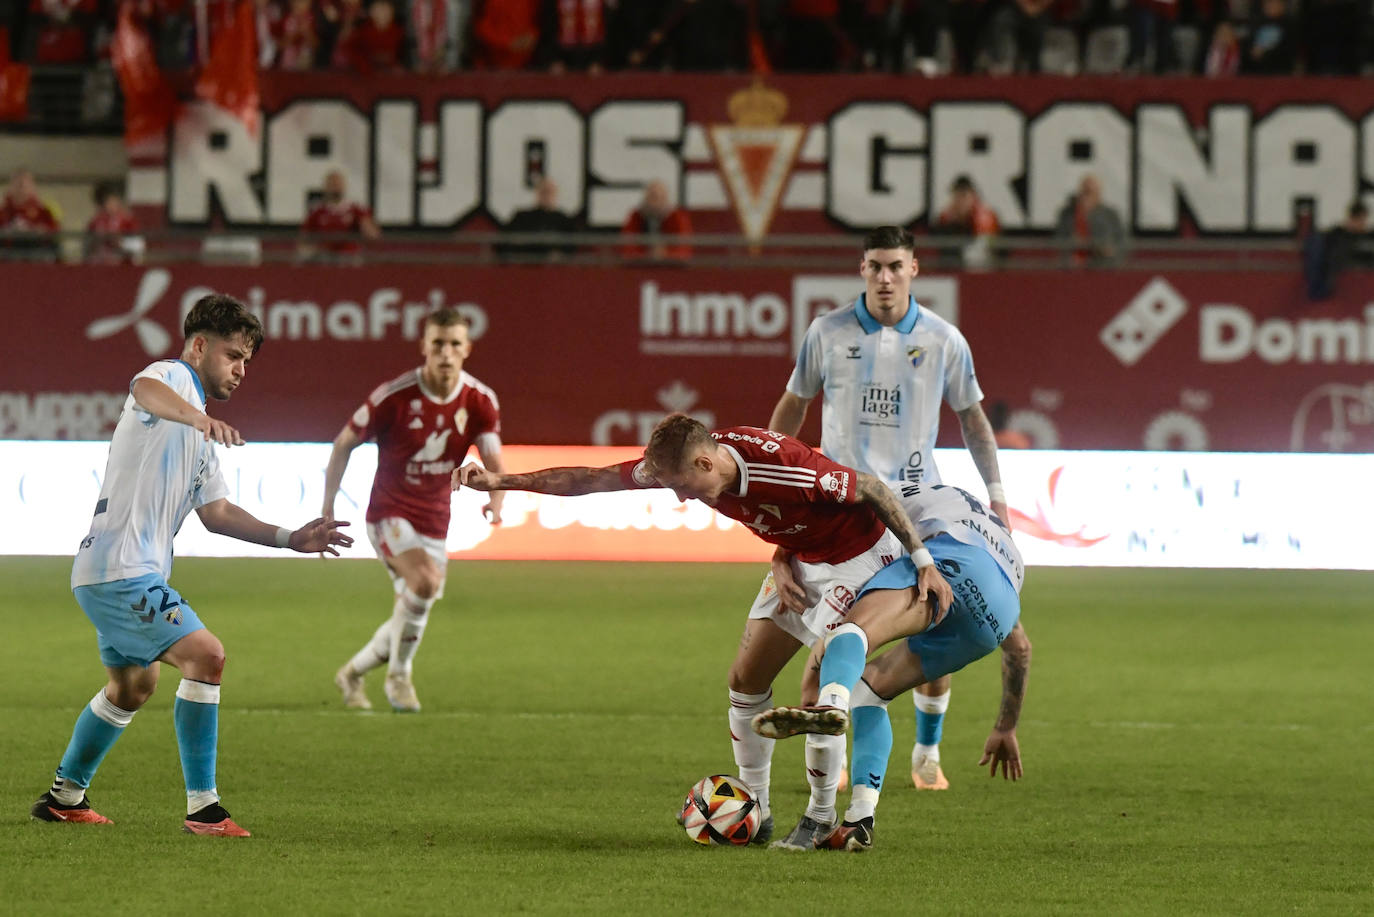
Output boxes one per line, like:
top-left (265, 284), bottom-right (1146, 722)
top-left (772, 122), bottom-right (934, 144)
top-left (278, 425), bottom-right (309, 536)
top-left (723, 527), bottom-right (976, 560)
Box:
top-left (348, 370), bottom-right (502, 538)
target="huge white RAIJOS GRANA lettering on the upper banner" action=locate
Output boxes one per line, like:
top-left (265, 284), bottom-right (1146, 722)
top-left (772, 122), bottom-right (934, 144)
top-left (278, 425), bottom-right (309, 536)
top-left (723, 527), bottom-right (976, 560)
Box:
top-left (160, 88), bottom-right (1374, 235)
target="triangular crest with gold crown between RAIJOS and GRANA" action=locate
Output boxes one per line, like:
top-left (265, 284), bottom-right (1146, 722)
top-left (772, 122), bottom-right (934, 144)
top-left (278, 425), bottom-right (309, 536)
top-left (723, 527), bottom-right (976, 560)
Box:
top-left (708, 80), bottom-right (805, 243)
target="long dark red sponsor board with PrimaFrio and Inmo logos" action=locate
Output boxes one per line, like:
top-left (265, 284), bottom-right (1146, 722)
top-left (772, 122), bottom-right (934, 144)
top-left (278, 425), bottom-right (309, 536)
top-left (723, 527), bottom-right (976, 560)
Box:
top-left (0, 265), bottom-right (1374, 452)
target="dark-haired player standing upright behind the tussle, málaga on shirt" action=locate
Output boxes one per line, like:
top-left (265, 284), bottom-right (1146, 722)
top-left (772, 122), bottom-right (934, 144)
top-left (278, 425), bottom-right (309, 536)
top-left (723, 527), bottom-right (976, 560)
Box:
top-left (768, 225), bottom-right (1010, 789)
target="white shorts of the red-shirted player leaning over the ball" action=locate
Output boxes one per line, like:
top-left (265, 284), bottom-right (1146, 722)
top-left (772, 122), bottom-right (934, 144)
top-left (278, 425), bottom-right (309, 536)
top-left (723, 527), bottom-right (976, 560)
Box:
top-left (749, 531), bottom-right (905, 646)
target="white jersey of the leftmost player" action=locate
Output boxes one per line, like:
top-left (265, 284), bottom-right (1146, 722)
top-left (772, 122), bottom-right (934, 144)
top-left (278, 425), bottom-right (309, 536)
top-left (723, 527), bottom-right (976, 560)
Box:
top-left (71, 360), bottom-right (229, 588)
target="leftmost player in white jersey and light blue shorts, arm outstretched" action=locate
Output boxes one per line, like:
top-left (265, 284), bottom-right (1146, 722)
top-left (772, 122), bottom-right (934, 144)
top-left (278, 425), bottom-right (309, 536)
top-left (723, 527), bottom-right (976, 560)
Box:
top-left (32, 296), bottom-right (353, 837)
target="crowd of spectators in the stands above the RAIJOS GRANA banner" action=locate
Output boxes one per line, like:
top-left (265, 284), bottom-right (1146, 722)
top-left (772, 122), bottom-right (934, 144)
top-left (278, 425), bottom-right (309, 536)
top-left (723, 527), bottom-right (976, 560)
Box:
top-left (0, 0), bottom-right (1374, 76)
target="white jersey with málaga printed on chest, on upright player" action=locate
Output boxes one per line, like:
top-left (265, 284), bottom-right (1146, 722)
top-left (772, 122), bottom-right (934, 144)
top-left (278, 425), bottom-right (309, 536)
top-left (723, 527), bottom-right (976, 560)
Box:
top-left (787, 296), bottom-right (982, 484)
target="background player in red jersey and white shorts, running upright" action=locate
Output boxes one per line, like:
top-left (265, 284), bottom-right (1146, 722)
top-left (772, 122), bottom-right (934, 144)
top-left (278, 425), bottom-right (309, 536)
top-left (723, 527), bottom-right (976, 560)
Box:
top-left (324, 309), bottom-right (504, 712)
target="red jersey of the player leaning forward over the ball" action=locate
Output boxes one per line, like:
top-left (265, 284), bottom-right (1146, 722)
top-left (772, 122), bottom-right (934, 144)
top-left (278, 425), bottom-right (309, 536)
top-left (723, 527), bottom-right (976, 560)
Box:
top-left (620, 426), bottom-right (886, 564)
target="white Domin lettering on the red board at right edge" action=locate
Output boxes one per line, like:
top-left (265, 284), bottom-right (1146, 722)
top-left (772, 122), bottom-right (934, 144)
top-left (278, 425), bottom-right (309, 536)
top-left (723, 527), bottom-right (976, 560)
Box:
top-left (1198, 304), bottom-right (1374, 364)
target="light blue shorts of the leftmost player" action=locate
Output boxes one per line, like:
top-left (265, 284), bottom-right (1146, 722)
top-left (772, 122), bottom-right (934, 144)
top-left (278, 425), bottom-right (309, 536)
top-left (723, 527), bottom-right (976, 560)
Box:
top-left (71, 573), bottom-right (205, 668)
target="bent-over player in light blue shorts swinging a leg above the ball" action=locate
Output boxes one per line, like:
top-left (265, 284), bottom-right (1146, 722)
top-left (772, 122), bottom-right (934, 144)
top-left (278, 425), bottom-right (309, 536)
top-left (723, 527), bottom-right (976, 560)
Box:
top-left (753, 484), bottom-right (1031, 851)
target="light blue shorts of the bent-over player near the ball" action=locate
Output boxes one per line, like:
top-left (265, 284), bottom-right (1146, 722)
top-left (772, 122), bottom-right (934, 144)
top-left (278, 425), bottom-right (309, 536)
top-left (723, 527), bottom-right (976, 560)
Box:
top-left (859, 535), bottom-right (1021, 679)
